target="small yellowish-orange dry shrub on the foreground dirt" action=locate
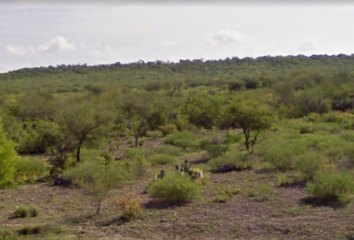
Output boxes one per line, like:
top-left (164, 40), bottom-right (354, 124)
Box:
top-left (114, 193), bottom-right (142, 220)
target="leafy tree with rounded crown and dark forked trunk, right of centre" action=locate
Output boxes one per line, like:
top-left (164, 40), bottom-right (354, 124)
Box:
top-left (222, 100), bottom-right (275, 154)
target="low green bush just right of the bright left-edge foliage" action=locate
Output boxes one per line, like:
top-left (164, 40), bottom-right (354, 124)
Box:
top-left (15, 157), bottom-right (48, 183)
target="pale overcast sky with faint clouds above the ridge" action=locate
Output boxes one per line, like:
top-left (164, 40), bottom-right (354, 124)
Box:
top-left (0, 0), bottom-right (354, 73)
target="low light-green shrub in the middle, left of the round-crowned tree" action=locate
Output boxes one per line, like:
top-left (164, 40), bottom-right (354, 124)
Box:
top-left (165, 131), bottom-right (199, 150)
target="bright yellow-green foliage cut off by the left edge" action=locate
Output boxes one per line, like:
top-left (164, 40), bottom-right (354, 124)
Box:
top-left (0, 119), bottom-right (18, 188)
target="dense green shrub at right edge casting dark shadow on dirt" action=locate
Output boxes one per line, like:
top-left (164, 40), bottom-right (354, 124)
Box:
top-left (306, 171), bottom-right (354, 205)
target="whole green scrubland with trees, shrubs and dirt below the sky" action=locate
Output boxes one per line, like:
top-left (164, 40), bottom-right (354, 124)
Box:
top-left (0, 55), bottom-right (354, 239)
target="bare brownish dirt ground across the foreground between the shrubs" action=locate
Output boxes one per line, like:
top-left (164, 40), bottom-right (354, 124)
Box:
top-left (0, 138), bottom-right (354, 240)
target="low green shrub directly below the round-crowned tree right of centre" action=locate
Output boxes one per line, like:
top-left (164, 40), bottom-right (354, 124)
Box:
top-left (208, 150), bottom-right (253, 171)
